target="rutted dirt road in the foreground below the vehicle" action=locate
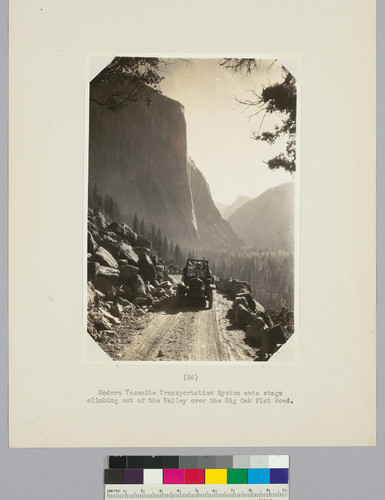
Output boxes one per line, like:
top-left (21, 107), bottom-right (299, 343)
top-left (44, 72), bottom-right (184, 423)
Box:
top-left (114, 294), bottom-right (255, 361)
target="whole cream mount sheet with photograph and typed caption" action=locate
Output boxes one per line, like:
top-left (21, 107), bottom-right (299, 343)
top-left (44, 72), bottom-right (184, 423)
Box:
top-left (8, 0), bottom-right (376, 449)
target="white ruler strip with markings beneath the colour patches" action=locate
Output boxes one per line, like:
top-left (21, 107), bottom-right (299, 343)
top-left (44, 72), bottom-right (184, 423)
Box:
top-left (105, 484), bottom-right (289, 500)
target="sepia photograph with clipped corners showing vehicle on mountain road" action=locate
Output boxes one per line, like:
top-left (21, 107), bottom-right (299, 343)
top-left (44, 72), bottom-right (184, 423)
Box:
top-left (86, 56), bottom-right (298, 362)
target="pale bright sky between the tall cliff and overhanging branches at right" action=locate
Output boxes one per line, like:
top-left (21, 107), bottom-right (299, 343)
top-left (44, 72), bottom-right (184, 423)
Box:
top-left (161, 59), bottom-right (293, 203)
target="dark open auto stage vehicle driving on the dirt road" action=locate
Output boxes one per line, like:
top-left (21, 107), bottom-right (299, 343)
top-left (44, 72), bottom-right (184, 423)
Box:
top-left (176, 259), bottom-right (215, 309)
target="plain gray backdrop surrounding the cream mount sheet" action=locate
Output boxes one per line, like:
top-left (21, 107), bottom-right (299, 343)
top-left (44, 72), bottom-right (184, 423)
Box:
top-left (0, 0), bottom-right (385, 500)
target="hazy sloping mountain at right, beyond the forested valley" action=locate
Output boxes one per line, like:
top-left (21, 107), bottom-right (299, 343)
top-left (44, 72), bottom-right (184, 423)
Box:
top-left (228, 182), bottom-right (295, 252)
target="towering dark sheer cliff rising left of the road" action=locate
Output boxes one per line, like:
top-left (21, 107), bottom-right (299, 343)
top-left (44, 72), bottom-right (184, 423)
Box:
top-left (89, 85), bottom-right (239, 254)
